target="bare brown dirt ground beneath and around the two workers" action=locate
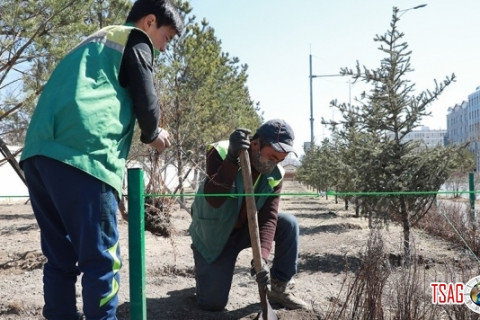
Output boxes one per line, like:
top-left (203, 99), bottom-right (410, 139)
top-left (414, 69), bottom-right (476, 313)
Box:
top-left (0, 181), bottom-right (472, 320)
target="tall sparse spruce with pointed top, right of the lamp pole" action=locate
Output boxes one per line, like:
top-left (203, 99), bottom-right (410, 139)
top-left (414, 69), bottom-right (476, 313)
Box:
top-left (332, 7), bottom-right (464, 259)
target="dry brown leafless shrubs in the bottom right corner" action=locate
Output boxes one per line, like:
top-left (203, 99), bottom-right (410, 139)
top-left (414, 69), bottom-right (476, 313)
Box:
top-left (325, 207), bottom-right (480, 320)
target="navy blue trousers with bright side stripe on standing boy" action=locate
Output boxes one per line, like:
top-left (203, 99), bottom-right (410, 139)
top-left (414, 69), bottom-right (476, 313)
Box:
top-left (22, 156), bottom-right (121, 320)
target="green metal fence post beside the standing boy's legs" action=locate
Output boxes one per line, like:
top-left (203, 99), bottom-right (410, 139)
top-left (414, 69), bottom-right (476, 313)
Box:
top-left (127, 168), bottom-right (147, 320)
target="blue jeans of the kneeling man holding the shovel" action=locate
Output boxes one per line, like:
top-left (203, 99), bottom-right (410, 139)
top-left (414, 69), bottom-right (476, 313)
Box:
top-left (192, 213), bottom-right (299, 311)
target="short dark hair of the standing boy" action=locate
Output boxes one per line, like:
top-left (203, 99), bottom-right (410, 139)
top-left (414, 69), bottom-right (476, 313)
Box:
top-left (126, 0), bottom-right (184, 36)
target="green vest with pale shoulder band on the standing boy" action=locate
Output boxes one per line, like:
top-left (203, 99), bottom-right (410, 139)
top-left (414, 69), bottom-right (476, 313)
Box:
top-left (21, 26), bottom-right (153, 194)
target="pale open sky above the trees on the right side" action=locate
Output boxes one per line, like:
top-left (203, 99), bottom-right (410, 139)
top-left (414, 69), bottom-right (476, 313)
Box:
top-left (190, 0), bottom-right (480, 153)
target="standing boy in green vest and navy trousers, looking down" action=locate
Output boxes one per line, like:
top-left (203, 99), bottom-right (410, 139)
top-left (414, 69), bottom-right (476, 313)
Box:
top-left (20, 0), bottom-right (183, 320)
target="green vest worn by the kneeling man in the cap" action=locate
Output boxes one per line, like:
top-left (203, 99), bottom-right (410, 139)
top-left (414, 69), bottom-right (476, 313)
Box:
top-left (189, 141), bottom-right (285, 263)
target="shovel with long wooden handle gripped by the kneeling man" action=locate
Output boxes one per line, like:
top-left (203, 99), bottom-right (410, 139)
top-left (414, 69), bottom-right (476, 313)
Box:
top-left (240, 150), bottom-right (278, 320)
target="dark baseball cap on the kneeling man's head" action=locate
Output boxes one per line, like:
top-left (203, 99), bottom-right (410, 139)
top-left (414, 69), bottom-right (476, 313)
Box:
top-left (256, 119), bottom-right (297, 155)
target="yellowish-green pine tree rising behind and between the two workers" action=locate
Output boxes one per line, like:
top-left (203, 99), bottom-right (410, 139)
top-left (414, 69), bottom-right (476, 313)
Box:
top-left (136, 1), bottom-right (261, 202)
